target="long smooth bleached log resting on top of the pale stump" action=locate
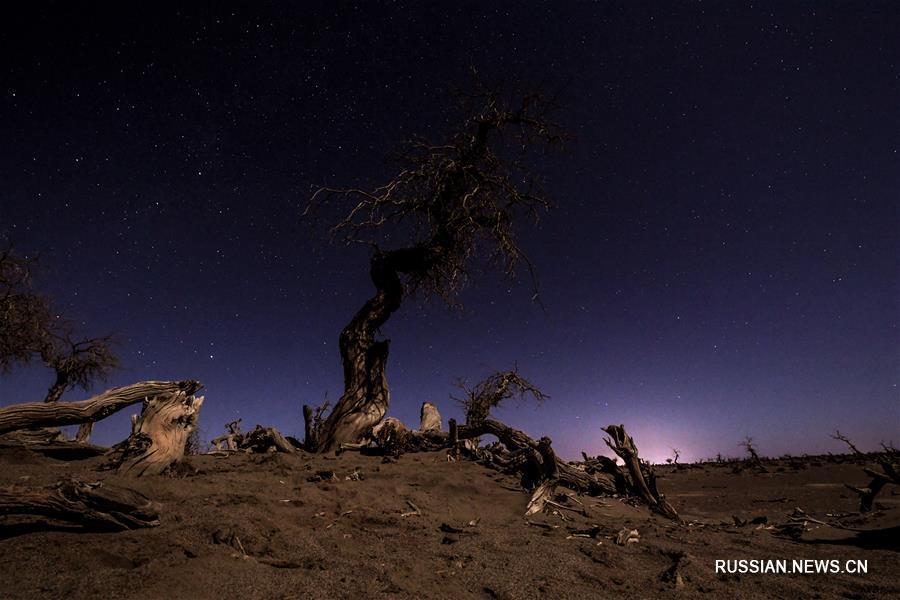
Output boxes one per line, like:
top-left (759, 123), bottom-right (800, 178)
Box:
top-left (0, 380), bottom-right (202, 434)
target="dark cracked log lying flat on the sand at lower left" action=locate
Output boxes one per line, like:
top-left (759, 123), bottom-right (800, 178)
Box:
top-left (0, 479), bottom-right (159, 531)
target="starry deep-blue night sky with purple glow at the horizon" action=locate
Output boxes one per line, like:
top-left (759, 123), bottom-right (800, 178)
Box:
top-left (0, 1), bottom-right (900, 460)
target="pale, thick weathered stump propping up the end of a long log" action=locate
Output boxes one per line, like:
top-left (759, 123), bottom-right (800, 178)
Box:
top-left (117, 390), bottom-right (203, 476)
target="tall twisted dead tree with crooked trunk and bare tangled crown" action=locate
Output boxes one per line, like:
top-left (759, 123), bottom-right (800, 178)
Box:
top-left (312, 87), bottom-right (560, 450)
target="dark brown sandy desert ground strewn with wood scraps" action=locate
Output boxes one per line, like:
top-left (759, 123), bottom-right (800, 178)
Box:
top-left (0, 448), bottom-right (900, 598)
